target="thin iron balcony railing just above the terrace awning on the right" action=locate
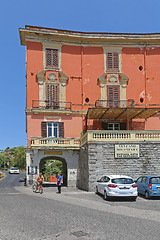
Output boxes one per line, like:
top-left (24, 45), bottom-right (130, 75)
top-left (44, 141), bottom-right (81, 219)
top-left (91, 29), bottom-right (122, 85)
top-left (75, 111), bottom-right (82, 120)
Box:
top-left (95, 99), bottom-right (134, 108)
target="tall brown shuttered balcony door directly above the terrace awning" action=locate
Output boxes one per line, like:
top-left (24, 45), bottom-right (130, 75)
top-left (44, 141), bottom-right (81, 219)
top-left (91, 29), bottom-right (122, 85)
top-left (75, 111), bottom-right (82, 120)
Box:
top-left (107, 86), bottom-right (119, 108)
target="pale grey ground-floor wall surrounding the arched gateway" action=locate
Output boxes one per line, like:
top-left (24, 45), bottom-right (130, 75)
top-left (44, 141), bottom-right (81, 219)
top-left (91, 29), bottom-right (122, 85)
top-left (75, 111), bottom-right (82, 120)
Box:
top-left (26, 149), bottom-right (79, 187)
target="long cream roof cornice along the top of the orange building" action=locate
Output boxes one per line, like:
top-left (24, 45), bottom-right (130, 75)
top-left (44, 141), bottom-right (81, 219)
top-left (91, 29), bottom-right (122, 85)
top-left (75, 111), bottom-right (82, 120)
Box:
top-left (19, 26), bottom-right (160, 45)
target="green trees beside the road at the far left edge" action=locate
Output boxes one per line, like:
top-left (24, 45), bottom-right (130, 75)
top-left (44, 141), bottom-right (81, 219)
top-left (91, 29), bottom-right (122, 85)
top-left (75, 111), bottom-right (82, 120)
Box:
top-left (0, 146), bottom-right (26, 169)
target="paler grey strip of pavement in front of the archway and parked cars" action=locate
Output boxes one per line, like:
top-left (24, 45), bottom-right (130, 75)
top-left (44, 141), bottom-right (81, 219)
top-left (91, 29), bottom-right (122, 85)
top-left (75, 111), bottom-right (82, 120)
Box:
top-left (15, 186), bottom-right (160, 223)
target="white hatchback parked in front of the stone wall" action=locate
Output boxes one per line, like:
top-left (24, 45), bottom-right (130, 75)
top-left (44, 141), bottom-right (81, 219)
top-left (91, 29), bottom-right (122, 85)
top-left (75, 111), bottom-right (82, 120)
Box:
top-left (96, 175), bottom-right (138, 200)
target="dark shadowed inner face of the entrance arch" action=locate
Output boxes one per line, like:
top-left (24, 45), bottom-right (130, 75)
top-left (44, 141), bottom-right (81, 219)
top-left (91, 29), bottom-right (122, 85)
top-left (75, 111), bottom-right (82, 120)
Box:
top-left (39, 155), bottom-right (68, 186)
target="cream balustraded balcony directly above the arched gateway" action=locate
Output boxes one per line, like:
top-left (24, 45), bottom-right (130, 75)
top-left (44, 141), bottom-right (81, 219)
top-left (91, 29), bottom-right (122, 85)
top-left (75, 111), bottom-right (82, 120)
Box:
top-left (30, 137), bottom-right (80, 150)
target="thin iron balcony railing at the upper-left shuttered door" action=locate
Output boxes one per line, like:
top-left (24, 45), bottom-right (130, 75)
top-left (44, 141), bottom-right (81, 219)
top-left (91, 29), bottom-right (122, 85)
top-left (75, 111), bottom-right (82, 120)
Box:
top-left (32, 100), bottom-right (72, 110)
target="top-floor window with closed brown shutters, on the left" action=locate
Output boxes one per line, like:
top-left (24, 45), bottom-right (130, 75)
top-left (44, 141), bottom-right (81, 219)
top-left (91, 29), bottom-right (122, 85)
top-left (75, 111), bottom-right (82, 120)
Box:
top-left (46, 48), bottom-right (59, 68)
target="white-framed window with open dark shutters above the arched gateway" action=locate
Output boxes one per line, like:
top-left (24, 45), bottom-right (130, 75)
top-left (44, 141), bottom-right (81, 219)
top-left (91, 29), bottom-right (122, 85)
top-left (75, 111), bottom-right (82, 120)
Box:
top-left (41, 122), bottom-right (64, 138)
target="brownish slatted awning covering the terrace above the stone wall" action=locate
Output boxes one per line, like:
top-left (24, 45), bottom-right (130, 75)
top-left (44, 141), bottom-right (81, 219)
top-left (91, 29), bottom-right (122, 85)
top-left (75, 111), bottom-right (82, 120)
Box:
top-left (87, 107), bottom-right (160, 121)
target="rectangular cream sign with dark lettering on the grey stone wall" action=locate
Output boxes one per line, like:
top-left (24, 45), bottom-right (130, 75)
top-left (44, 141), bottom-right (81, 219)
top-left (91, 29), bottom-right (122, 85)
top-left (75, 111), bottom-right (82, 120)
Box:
top-left (115, 144), bottom-right (139, 158)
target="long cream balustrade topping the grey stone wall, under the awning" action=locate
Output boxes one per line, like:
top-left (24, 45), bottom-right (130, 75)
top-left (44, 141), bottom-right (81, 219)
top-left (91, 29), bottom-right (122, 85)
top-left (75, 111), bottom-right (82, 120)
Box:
top-left (80, 130), bottom-right (160, 146)
